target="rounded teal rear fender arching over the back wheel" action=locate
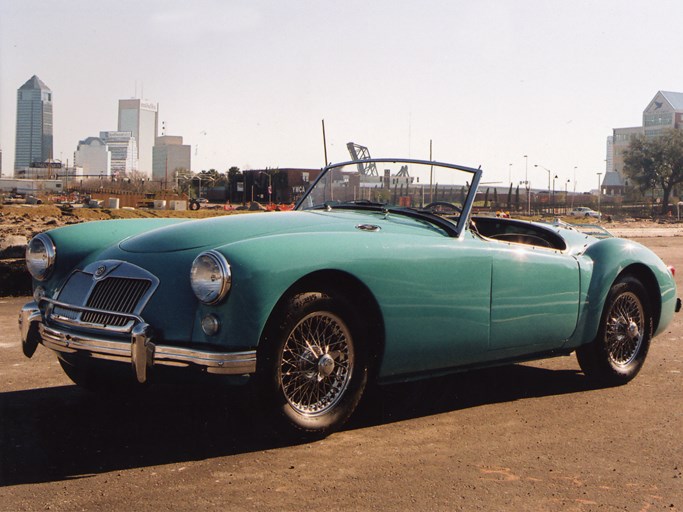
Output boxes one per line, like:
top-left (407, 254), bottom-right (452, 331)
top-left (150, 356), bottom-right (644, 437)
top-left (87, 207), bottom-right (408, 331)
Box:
top-left (570, 238), bottom-right (676, 346)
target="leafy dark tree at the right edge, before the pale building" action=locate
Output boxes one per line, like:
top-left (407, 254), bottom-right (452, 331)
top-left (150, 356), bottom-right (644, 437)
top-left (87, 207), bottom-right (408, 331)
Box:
top-left (624, 128), bottom-right (683, 214)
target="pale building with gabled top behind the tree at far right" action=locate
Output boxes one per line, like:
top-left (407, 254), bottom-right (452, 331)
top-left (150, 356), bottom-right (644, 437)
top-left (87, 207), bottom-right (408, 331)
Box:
top-left (612, 91), bottom-right (683, 195)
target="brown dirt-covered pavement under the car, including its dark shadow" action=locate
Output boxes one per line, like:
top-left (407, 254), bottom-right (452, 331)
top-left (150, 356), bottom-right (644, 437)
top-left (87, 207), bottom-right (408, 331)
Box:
top-left (0, 212), bottom-right (683, 511)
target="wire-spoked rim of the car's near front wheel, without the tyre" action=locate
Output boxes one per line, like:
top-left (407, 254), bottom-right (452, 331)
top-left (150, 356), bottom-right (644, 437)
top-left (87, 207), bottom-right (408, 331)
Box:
top-left (279, 311), bottom-right (354, 416)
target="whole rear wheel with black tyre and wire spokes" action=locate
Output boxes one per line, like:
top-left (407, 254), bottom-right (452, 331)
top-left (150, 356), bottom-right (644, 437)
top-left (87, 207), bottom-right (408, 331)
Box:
top-left (576, 276), bottom-right (653, 385)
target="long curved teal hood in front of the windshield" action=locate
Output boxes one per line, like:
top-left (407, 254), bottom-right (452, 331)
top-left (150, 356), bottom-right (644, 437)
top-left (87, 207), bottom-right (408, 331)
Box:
top-left (119, 211), bottom-right (444, 253)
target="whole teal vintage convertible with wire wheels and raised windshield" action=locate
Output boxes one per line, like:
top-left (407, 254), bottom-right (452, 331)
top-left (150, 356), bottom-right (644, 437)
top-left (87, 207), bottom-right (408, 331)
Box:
top-left (20, 159), bottom-right (680, 435)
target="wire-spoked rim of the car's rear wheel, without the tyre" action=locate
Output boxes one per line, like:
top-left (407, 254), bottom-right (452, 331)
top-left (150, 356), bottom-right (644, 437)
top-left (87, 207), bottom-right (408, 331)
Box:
top-left (605, 292), bottom-right (645, 366)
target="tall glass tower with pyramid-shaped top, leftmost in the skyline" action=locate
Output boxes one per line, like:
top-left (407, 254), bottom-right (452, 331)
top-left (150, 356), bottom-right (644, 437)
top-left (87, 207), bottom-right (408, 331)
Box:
top-left (14, 75), bottom-right (52, 170)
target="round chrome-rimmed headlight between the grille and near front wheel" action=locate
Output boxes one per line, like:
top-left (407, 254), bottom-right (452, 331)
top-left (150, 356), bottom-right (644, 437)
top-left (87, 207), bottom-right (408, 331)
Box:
top-left (190, 251), bottom-right (232, 304)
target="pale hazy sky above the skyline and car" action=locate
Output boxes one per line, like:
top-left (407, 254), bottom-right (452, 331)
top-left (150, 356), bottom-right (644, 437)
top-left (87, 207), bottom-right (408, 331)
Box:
top-left (0, 0), bottom-right (683, 190)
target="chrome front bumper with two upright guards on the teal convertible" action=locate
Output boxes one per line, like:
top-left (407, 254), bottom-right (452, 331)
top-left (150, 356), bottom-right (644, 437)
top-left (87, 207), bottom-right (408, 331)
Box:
top-left (19, 302), bottom-right (256, 382)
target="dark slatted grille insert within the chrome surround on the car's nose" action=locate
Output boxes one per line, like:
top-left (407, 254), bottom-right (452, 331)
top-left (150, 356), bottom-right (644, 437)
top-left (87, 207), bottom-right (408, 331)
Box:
top-left (81, 277), bottom-right (151, 327)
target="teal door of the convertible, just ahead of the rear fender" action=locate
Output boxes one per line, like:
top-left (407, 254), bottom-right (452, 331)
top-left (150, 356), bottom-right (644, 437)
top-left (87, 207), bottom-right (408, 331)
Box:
top-left (489, 241), bottom-right (580, 355)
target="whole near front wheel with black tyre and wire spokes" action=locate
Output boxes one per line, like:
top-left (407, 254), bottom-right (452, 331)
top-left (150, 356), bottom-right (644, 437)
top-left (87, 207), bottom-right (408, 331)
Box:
top-left (256, 292), bottom-right (368, 436)
